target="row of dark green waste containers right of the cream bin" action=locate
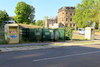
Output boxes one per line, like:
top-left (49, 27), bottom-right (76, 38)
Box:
top-left (20, 28), bottom-right (72, 42)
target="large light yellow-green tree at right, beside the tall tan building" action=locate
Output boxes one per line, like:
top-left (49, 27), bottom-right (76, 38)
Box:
top-left (73, 0), bottom-right (100, 28)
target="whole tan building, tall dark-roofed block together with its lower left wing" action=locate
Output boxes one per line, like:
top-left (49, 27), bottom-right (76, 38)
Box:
top-left (45, 7), bottom-right (77, 29)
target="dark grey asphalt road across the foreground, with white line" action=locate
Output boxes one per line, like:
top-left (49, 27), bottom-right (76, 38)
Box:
top-left (0, 46), bottom-right (100, 67)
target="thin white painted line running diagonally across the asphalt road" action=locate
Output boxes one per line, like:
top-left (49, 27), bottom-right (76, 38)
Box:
top-left (33, 51), bottom-right (100, 62)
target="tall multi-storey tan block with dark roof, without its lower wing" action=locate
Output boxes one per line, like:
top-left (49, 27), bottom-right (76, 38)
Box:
top-left (58, 7), bottom-right (77, 29)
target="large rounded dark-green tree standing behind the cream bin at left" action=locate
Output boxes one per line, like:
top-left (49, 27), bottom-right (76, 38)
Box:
top-left (14, 1), bottom-right (35, 24)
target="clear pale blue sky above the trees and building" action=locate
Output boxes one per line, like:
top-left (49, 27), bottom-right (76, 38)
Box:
top-left (0, 0), bottom-right (82, 20)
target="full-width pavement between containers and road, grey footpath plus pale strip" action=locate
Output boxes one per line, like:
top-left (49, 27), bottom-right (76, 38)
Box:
top-left (0, 40), bottom-right (100, 52)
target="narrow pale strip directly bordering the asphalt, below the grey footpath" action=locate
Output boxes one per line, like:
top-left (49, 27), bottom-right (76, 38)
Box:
top-left (0, 40), bottom-right (100, 52)
